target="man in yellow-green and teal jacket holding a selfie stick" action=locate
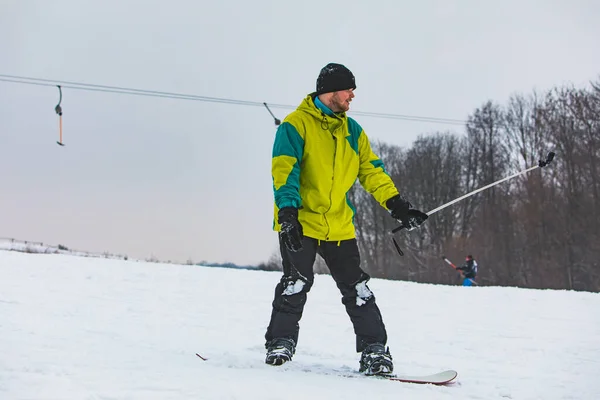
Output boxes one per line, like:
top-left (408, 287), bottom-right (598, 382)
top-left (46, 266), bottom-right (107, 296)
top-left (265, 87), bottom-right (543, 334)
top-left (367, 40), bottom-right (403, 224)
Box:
top-left (265, 63), bottom-right (427, 375)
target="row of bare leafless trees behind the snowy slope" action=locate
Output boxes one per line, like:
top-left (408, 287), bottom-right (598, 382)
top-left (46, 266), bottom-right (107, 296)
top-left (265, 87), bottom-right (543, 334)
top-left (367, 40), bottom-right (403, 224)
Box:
top-left (262, 76), bottom-right (600, 292)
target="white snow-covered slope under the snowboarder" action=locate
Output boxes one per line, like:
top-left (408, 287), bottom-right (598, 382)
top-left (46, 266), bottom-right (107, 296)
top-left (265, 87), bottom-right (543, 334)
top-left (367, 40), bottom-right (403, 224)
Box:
top-left (0, 251), bottom-right (600, 400)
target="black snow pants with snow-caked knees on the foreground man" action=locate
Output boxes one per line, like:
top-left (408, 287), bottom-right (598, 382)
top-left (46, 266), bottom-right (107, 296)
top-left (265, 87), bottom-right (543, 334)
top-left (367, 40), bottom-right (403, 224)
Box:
top-left (265, 236), bottom-right (387, 352)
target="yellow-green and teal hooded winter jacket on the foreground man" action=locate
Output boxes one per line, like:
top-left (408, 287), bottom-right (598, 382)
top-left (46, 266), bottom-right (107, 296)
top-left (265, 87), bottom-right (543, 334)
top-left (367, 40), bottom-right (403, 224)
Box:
top-left (271, 94), bottom-right (398, 241)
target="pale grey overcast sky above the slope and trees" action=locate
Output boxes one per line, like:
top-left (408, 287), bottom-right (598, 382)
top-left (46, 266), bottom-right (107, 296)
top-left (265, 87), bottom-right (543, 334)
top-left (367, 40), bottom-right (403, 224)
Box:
top-left (0, 0), bottom-right (600, 264)
